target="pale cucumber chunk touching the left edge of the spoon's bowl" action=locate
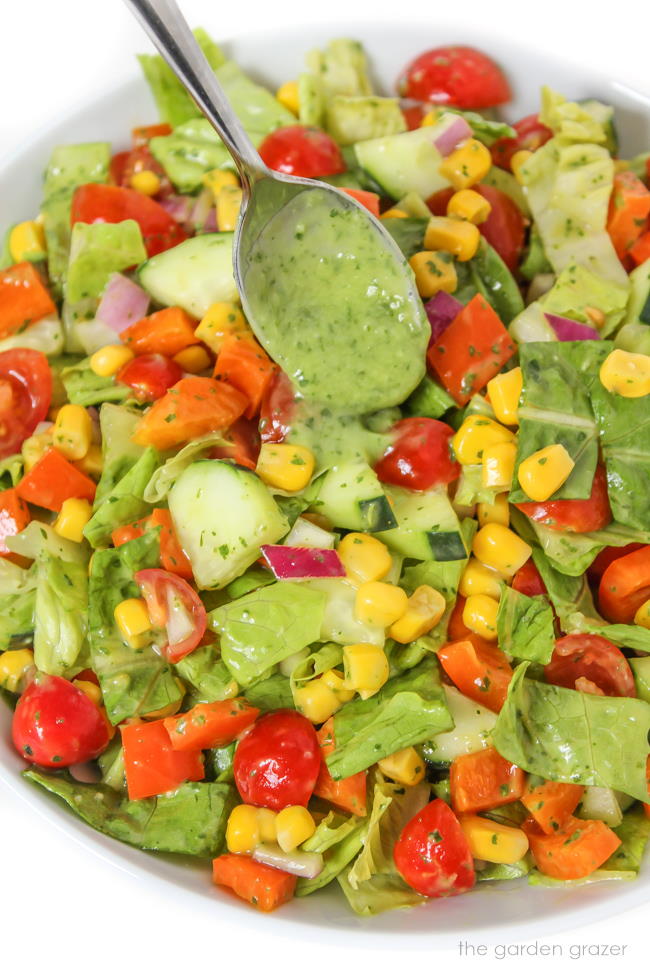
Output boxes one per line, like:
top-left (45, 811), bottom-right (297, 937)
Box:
top-left (138, 233), bottom-right (238, 318)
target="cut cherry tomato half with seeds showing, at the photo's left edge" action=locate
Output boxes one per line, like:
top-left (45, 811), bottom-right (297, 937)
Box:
top-left (0, 349), bottom-right (52, 458)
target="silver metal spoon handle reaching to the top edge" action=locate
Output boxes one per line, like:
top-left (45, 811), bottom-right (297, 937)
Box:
top-left (125, 0), bottom-right (266, 186)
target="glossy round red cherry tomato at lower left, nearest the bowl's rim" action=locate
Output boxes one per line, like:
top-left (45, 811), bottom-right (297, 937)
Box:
top-left (11, 674), bottom-right (110, 768)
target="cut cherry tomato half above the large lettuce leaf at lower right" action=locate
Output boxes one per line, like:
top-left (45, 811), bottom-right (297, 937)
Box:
top-left (544, 633), bottom-right (636, 697)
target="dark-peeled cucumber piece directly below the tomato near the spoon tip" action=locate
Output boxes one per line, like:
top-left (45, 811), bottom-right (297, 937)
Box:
top-left (378, 488), bottom-right (467, 562)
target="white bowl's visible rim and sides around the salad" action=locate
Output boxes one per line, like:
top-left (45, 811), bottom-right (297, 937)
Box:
top-left (0, 22), bottom-right (650, 948)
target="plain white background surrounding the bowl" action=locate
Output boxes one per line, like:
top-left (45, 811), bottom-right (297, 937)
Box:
top-left (0, 0), bottom-right (650, 975)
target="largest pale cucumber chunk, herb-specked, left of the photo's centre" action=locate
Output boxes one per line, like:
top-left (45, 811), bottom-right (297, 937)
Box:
top-left (169, 460), bottom-right (289, 589)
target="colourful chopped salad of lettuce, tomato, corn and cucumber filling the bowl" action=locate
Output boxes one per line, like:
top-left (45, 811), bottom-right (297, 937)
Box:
top-left (0, 31), bottom-right (650, 916)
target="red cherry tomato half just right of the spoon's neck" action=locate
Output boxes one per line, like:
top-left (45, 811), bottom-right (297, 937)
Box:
top-left (258, 125), bottom-right (347, 179)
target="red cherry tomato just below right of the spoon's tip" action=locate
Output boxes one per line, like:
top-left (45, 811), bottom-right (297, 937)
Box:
top-left (375, 416), bottom-right (460, 491)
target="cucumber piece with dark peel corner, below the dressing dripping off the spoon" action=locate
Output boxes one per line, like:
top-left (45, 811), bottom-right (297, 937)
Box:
top-left (314, 460), bottom-right (397, 532)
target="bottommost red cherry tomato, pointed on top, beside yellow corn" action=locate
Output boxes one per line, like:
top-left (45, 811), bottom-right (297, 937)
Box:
top-left (393, 799), bottom-right (476, 897)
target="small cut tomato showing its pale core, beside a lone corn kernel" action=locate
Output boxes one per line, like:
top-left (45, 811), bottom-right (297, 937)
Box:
top-left (135, 569), bottom-right (208, 664)
